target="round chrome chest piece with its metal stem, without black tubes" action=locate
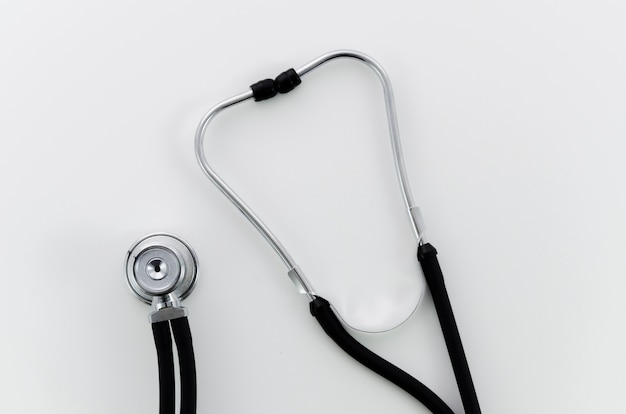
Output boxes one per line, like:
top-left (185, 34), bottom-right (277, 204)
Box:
top-left (125, 233), bottom-right (198, 322)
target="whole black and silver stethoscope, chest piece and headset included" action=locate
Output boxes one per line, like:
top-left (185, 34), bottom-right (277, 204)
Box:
top-left (126, 50), bottom-right (480, 414)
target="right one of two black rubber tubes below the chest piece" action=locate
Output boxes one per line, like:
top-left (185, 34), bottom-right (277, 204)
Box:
top-left (170, 317), bottom-right (197, 414)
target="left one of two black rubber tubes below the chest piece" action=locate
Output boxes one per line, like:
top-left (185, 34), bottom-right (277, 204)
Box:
top-left (152, 321), bottom-right (176, 414)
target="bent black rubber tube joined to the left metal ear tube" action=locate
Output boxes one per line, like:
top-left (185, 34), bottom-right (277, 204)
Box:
top-left (310, 296), bottom-right (453, 414)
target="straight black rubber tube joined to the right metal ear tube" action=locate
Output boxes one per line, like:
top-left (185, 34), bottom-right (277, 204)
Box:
top-left (417, 243), bottom-right (480, 414)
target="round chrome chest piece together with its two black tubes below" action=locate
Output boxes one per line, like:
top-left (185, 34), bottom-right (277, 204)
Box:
top-left (126, 233), bottom-right (198, 414)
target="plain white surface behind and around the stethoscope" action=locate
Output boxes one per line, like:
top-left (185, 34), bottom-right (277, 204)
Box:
top-left (0, 0), bottom-right (626, 414)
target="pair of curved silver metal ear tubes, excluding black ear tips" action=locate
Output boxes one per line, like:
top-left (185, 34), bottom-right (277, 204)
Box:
top-left (195, 50), bottom-right (424, 300)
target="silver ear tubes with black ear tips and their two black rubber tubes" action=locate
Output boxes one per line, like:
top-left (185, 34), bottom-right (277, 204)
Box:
top-left (188, 51), bottom-right (481, 414)
